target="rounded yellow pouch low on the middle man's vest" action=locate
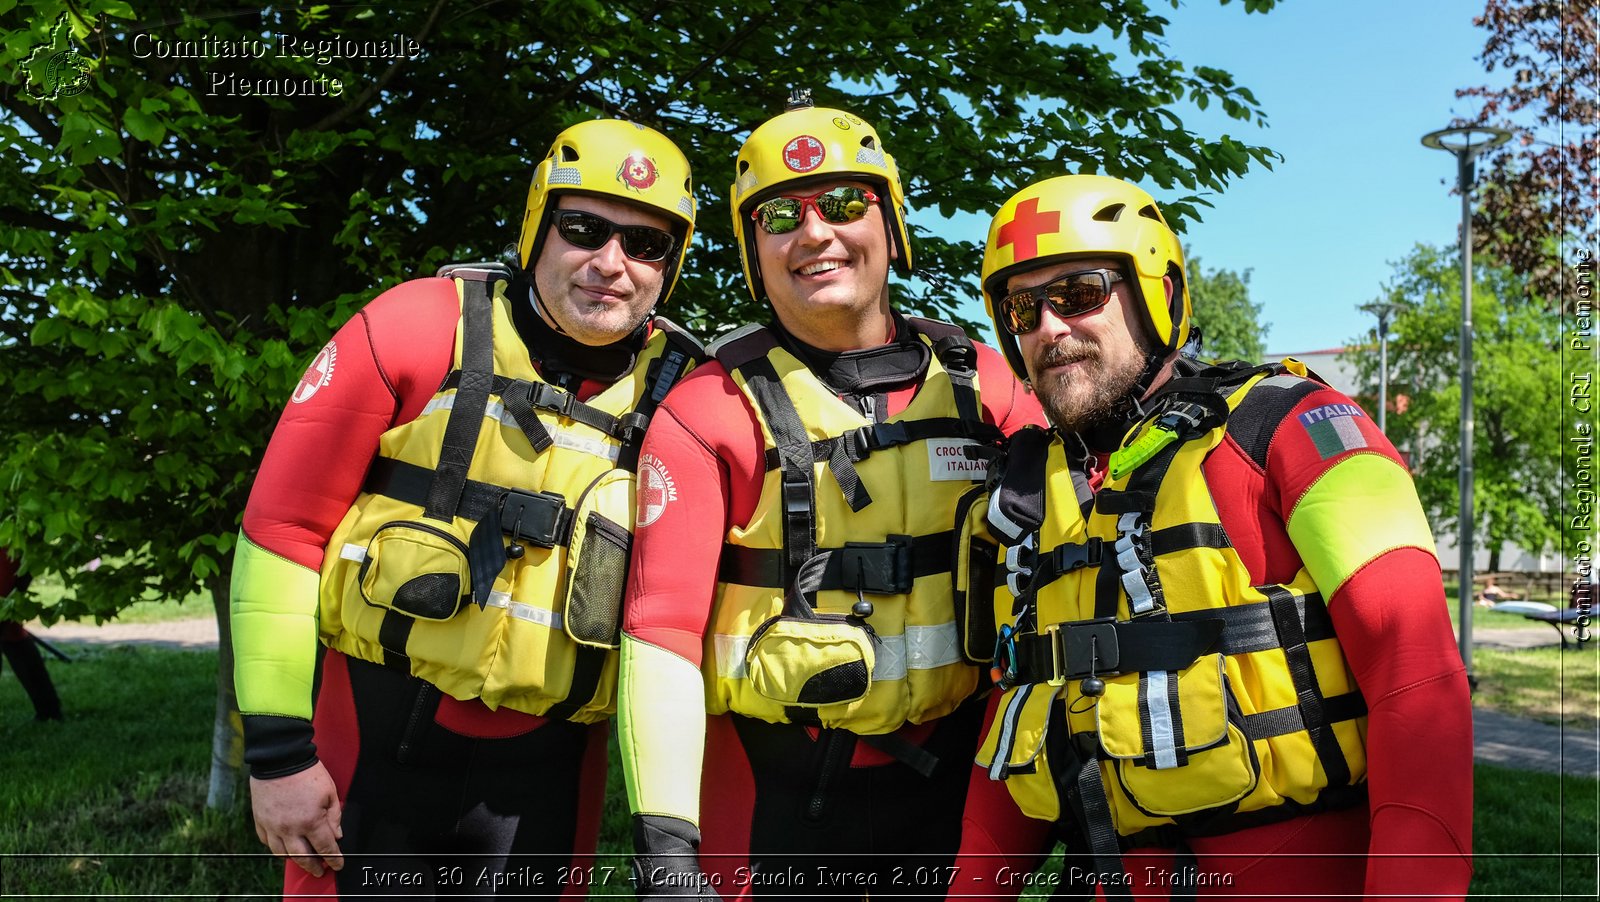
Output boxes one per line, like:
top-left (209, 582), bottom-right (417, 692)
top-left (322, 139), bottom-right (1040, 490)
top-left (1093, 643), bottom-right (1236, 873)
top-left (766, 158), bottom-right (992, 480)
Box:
top-left (744, 614), bottom-right (877, 708)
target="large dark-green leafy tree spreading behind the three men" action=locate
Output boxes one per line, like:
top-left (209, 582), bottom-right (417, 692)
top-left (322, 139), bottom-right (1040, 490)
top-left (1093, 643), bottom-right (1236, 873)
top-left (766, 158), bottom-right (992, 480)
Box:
top-left (0, 0), bottom-right (1272, 802)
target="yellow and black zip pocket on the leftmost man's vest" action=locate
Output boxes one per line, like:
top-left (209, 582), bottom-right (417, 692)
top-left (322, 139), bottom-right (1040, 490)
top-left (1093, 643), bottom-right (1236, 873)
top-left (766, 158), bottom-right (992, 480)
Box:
top-left (366, 520), bottom-right (472, 621)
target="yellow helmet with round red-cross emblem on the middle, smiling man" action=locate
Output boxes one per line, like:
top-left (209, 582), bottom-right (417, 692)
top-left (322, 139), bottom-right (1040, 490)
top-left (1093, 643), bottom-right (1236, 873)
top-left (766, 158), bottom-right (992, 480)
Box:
top-left (728, 93), bottom-right (912, 301)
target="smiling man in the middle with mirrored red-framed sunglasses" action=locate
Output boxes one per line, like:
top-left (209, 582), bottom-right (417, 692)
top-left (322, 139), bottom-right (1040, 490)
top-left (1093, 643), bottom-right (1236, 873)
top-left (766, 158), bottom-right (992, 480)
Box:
top-left (618, 95), bottom-right (1042, 899)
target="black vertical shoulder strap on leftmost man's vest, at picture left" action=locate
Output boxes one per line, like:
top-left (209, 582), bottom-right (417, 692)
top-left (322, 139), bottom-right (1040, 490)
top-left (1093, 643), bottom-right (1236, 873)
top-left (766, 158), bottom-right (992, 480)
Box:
top-left (422, 278), bottom-right (494, 523)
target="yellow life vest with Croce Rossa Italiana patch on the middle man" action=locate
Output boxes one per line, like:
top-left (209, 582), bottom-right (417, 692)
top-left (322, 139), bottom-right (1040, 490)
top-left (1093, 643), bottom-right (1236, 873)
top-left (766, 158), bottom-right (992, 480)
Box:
top-left (704, 320), bottom-right (1000, 736)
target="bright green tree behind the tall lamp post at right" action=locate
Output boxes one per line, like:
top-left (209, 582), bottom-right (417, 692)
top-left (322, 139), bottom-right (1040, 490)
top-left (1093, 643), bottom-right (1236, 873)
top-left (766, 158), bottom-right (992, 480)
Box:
top-left (1349, 245), bottom-right (1573, 571)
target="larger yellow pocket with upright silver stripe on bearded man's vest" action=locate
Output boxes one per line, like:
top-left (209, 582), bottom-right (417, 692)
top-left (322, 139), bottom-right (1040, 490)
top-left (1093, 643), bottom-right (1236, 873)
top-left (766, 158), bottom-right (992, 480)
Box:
top-left (1094, 654), bottom-right (1261, 817)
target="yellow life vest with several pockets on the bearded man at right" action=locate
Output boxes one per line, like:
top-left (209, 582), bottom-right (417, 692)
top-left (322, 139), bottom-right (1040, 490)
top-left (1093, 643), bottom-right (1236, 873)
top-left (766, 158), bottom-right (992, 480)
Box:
top-left (978, 361), bottom-right (1366, 860)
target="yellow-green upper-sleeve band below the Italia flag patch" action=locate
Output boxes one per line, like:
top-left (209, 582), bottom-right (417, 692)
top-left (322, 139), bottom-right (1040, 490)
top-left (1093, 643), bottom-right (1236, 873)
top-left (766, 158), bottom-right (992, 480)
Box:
top-left (1288, 453), bottom-right (1437, 601)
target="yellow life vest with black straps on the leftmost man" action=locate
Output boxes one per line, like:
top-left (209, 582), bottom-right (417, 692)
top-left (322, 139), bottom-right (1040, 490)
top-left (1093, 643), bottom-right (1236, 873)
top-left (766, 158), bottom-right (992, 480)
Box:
top-left (320, 260), bottom-right (702, 723)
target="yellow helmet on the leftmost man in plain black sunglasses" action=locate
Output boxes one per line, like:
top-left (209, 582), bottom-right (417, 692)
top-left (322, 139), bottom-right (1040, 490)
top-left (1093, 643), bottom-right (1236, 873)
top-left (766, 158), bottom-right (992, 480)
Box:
top-left (517, 118), bottom-right (694, 304)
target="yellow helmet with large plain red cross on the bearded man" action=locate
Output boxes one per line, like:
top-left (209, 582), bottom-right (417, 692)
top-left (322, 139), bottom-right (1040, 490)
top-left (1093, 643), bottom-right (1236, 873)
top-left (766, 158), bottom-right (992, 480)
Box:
top-left (982, 176), bottom-right (1192, 379)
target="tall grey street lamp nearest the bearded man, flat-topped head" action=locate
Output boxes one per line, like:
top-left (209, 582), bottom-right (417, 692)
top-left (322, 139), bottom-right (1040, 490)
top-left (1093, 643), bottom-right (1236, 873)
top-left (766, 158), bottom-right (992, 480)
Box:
top-left (1422, 126), bottom-right (1510, 681)
